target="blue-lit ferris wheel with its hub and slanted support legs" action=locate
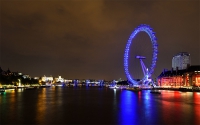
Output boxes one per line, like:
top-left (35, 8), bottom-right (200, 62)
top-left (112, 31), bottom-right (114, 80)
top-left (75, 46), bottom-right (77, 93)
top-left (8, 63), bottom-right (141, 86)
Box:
top-left (124, 24), bottom-right (158, 85)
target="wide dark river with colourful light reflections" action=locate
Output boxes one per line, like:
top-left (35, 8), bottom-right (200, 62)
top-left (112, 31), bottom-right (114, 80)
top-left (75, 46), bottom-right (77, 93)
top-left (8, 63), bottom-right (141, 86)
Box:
top-left (0, 87), bottom-right (200, 125)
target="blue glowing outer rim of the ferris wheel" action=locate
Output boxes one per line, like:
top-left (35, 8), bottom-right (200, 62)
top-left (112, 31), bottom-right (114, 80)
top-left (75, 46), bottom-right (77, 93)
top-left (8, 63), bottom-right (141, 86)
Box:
top-left (124, 24), bottom-right (158, 84)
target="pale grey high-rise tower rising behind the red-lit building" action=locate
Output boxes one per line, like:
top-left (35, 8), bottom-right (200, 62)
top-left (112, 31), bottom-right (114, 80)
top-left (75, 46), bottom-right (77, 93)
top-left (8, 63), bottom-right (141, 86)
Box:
top-left (172, 52), bottom-right (190, 70)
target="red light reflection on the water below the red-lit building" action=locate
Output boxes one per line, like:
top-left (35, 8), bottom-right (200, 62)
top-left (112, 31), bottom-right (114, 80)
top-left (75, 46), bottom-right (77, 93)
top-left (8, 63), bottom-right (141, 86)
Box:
top-left (161, 91), bottom-right (200, 125)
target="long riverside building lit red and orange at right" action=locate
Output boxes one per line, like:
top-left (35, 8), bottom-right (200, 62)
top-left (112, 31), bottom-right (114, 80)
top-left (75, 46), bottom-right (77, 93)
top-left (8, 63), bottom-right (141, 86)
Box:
top-left (157, 65), bottom-right (200, 87)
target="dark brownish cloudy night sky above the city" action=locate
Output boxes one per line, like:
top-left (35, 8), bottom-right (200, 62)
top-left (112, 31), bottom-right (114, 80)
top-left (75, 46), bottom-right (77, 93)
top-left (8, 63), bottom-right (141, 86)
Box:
top-left (0, 0), bottom-right (200, 80)
